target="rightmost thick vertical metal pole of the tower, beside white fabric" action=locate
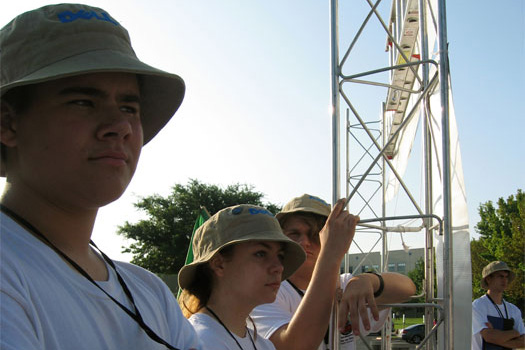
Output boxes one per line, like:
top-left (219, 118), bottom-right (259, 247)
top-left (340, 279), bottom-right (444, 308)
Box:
top-left (438, 0), bottom-right (454, 349)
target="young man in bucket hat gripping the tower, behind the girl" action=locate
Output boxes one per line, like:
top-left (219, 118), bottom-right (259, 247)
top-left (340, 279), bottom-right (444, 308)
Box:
top-left (252, 194), bottom-right (416, 350)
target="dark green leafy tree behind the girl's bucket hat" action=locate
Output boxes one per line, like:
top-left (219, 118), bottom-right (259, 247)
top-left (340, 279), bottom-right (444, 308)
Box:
top-left (118, 179), bottom-right (280, 274)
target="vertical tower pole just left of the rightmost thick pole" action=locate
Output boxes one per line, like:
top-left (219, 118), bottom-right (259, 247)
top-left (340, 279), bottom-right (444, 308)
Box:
top-left (419, 0), bottom-right (435, 350)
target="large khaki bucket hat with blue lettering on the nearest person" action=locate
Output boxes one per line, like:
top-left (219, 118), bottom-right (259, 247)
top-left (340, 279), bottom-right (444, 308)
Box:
top-left (0, 4), bottom-right (185, 176)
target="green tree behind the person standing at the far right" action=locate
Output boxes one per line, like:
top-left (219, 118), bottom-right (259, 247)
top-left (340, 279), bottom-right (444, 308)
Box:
top-left (470, 189), bottom-right (525, 312)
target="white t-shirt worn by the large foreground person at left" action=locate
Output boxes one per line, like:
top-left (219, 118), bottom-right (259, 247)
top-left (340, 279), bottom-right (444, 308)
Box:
top-left (0, 213), bottom-right (201, 350)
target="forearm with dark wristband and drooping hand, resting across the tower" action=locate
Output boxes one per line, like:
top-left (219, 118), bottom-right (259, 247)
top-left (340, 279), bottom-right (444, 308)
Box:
top-left (338, 272), bottom-right (416, 335)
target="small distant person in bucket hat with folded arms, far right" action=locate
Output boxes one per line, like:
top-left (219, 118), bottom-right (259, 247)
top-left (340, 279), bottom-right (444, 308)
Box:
top-left (472, 261), bottom-right (525, 350)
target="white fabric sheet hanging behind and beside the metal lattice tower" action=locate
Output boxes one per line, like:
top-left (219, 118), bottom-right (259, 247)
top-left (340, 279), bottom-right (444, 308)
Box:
top-left (385, 0), bottom-right (472, 349)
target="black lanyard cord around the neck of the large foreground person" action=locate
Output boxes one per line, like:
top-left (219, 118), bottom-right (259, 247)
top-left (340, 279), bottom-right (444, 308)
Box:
top-left (0, 204), bottom-right (179, 350)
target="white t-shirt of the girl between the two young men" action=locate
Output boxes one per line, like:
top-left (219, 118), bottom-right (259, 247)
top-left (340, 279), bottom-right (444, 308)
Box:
top-left (189, 313), bottom-right (275, 350)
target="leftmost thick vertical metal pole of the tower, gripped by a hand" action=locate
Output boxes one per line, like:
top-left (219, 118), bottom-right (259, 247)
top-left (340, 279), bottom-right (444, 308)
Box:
top-left (330, 0), bottom-right (340, 350)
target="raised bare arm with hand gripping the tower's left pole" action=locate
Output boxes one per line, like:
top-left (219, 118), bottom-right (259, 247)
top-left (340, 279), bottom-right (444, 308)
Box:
top-left (270, 199), bottom-right (359, 350)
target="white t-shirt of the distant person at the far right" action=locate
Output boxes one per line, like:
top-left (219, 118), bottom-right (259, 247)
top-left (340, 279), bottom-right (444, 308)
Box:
top-left (472, 295), bottom-right (525, 350)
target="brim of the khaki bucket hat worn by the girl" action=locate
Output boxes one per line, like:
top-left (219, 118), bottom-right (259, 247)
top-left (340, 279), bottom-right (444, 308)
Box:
top-left (178, 232), bottom-right (306, 289)
